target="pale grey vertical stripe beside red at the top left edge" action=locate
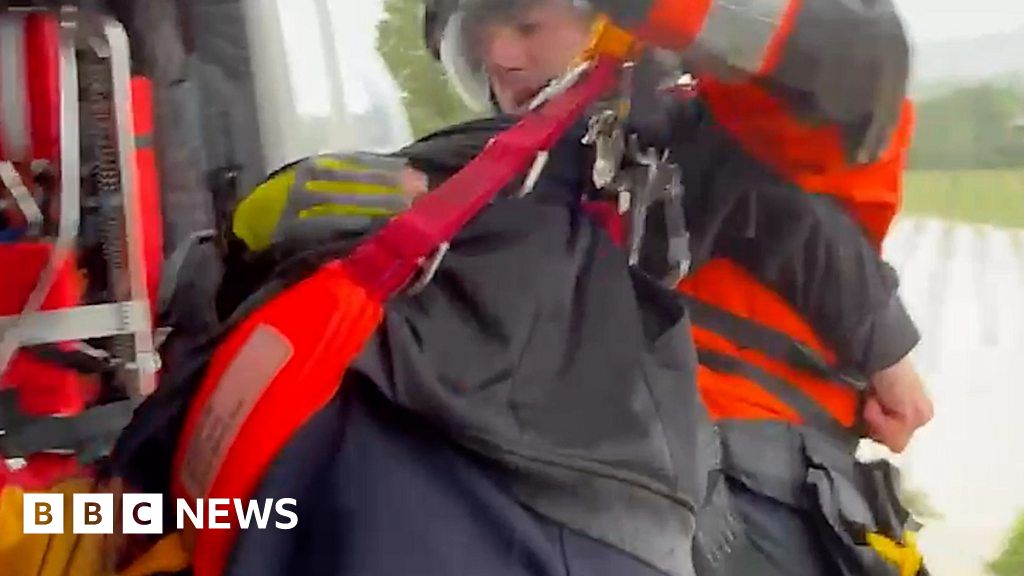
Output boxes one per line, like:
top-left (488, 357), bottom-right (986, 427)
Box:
top-left (0, 13), bottom-right (32, 161)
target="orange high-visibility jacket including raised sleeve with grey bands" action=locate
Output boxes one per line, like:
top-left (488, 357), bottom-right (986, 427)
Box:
top-left (593, 0), bottom-right (914, 428)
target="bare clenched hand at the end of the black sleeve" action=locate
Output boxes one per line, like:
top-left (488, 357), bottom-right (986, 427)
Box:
top-left (864, 358), bottom-right (934, 453)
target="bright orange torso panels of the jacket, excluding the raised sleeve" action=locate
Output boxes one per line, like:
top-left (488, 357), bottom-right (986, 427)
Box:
top-left (679, 79), bottom-right (913, 429)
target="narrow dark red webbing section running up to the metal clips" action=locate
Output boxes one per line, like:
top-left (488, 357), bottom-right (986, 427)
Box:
top-left (345, 57), bottom-right (621, 299)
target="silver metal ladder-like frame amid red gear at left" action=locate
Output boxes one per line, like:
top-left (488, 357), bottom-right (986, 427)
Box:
top-left (0, 8), bottom-right (160, 397)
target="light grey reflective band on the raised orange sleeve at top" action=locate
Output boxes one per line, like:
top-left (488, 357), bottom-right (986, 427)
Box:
top-left (694, 0), bottom-right (791, 74)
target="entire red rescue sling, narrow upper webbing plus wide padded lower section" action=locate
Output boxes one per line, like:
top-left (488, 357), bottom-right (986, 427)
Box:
top-left (172, 58), bottom-right (620, 576)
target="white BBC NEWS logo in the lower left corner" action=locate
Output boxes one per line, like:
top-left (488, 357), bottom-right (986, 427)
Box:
top-left (23, 493), bottom-right (299, 534)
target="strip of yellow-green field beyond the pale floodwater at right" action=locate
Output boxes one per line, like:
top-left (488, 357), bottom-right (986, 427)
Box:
top-left (903, 169), bottom-right (1024, 228)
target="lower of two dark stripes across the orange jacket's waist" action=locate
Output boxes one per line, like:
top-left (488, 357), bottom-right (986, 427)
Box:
top-left (697, 349), bottom-right (857, 441)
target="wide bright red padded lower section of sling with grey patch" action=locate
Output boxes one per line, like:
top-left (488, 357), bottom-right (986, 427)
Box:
top-left (172, 262), bottom-right (384, 576)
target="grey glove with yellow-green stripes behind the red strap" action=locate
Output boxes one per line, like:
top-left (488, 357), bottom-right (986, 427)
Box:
top-left (232, 153), bottom-right (427, 252)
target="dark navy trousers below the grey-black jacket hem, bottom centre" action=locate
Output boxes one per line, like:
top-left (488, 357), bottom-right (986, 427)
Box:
top-left (227, 386), bottom-right (665, 576)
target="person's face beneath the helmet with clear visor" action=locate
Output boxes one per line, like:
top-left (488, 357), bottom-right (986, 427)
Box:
top-left (475, 0), bottom-right (591, 113)
